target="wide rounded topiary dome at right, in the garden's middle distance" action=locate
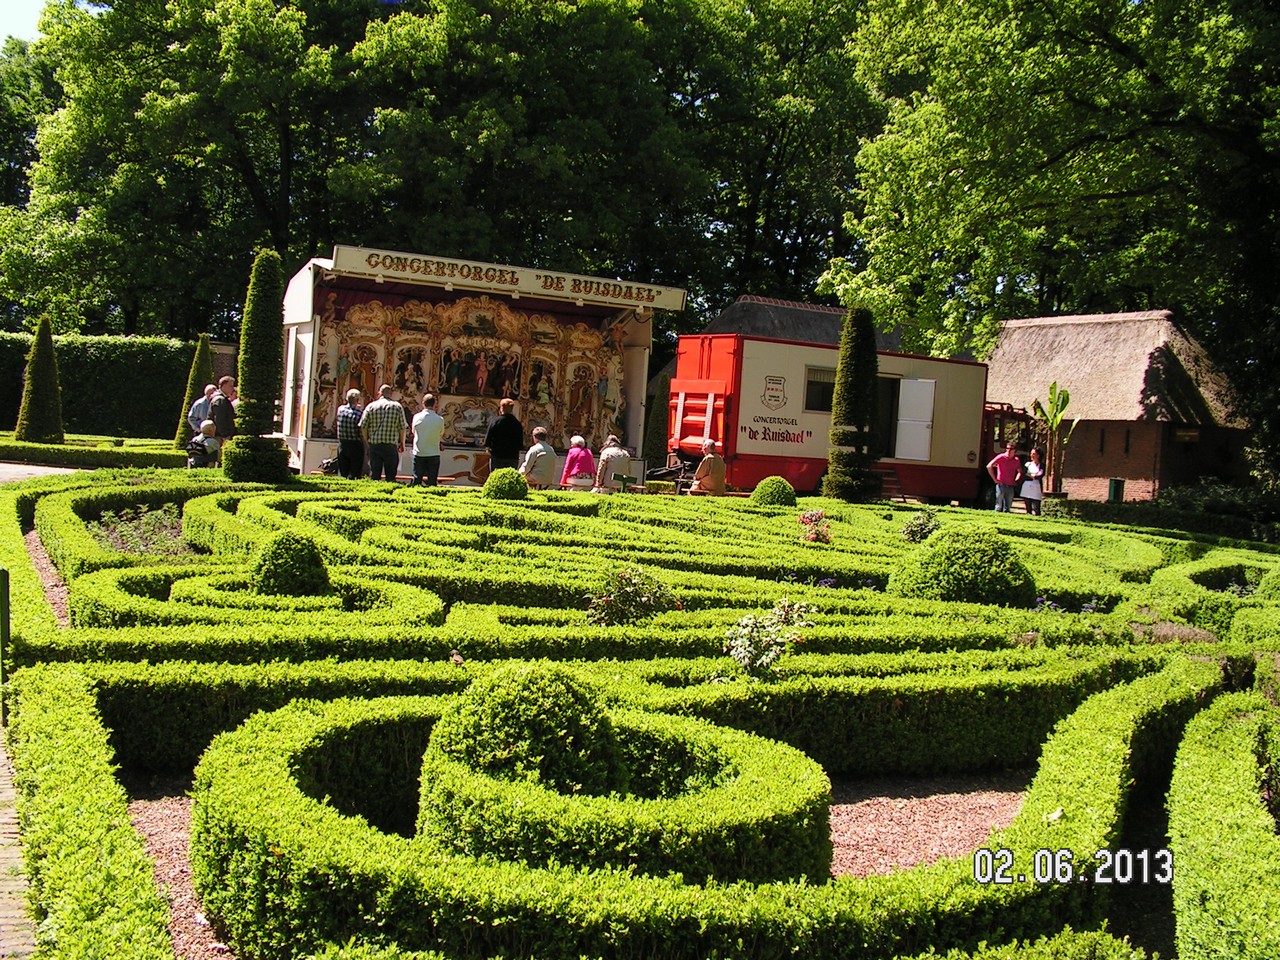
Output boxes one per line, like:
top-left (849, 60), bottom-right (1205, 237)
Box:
top-left (884, 529), bottom-right (1036, 607)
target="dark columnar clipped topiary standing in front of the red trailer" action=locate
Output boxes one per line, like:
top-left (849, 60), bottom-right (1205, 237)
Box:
top-left (822, 306), bottom-right (881, 503)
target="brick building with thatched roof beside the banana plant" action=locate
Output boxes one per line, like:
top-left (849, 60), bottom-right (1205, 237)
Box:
top-left (987, 310), bottom-right (1248, 499)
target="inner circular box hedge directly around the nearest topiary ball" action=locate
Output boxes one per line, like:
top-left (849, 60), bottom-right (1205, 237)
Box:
top-left (417, 710), bottom-right (831, 883)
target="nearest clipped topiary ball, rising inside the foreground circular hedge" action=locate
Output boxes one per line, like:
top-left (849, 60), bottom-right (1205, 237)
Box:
top-left (428, 663), bottom-right (626, 795)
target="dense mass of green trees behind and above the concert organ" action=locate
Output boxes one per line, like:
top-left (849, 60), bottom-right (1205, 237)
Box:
top-left (0, 0), bottom-right (878, 337)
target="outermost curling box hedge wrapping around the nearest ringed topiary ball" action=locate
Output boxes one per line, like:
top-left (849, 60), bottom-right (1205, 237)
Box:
top-left (192, 662), bottom-right (1221, 960)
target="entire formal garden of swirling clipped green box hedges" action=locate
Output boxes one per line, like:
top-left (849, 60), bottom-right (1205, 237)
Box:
top-left (0, 471), bottom-right (1280, 960)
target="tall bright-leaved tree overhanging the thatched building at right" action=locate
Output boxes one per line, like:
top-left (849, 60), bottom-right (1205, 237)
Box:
top-left (828, 0), bottom-right (1280, 470)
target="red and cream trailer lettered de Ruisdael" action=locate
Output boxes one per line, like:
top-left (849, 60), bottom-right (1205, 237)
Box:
top-left (667, 334), bottom-right (1029, 502)
